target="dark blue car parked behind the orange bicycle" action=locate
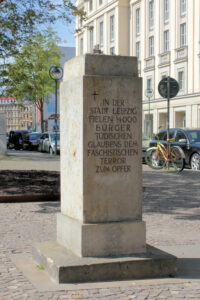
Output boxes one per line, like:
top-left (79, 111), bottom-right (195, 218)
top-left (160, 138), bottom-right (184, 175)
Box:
top-left (150, 128), bottom-right (200, 170)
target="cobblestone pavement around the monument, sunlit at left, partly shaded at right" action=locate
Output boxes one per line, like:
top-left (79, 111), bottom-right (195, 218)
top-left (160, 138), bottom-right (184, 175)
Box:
top-left (0, 170), bottom-right (200, 300)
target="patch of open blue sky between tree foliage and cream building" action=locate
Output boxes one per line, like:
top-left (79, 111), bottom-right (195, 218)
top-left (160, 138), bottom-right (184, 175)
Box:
top-left (52, 19), bottom-right (75, 47)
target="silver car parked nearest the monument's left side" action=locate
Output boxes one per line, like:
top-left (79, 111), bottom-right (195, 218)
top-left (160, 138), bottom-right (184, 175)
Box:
top-left (38, 132), bottom-right (60, 154)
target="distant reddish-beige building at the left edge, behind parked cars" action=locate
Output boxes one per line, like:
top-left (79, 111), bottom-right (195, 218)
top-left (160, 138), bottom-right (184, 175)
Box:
top-left (0, 97), bottom-right (34, 132)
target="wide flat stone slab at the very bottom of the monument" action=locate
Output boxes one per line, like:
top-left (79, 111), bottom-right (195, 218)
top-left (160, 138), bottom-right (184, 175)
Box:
top-left (33, 241), bottom-right (177, 283)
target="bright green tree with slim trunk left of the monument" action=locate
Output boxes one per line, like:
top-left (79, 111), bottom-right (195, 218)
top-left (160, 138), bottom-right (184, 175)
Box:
top-left (0, 29), bottom-right (62, 132)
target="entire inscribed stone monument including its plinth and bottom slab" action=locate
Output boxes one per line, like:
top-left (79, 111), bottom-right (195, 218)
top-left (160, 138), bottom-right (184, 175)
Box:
top-left (34, 54), bottom-right (176, 283)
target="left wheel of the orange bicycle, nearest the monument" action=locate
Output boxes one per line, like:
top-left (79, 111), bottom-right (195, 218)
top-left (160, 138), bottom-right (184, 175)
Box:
top-left (145, 147), bottom-right (166, 169)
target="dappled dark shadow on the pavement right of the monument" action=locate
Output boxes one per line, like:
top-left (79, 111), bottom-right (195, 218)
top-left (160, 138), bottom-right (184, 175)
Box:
top-left (143, 170), bottom-right (200, 220)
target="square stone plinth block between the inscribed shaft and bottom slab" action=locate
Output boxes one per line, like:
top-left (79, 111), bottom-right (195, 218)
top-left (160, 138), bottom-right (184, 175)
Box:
top-left (57, 213), bottom-right (146, 257)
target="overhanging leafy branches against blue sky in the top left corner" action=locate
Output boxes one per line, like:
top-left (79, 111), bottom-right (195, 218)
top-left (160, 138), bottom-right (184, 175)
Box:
top-left (0, 0), bottom-right (85, 64)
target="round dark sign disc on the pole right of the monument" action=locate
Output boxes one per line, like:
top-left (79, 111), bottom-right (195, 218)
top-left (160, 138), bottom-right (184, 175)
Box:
top-left (158, 76), bottom-right (179, 98)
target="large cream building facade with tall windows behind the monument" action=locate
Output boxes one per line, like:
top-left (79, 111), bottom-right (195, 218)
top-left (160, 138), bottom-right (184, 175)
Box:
top-left (76, 0), bottom-right (200, 133)
